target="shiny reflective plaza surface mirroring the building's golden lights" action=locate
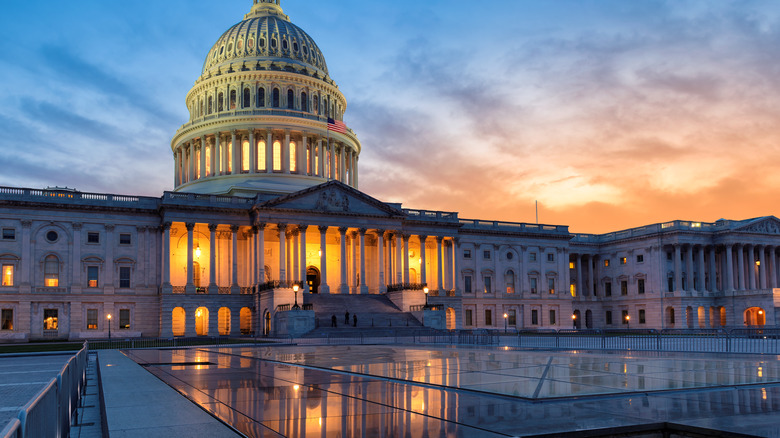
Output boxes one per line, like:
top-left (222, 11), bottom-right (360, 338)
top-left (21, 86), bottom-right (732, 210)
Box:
top-left (126, 346), bottom-right (780, 437)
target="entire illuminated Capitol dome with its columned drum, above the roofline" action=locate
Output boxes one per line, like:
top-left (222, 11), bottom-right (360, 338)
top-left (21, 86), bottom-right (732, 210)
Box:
top-left (171, 0), bottom-right (361, 197)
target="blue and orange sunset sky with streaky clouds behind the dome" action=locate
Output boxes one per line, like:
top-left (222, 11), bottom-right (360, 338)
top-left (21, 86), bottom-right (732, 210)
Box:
top-left (0, 0), bottom-right (780, 233)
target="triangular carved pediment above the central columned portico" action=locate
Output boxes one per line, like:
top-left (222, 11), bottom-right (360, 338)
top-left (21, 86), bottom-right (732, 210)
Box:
top-left (258, 181), bottom-right (403, 216)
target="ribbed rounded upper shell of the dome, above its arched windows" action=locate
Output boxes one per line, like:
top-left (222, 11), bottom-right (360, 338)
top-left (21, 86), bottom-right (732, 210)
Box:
top-left (203, 0), bottom-right (328, 77)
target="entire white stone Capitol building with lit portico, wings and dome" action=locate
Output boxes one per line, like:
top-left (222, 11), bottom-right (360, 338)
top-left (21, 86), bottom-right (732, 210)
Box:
top-left (0, 0), bottom-right (780, 341)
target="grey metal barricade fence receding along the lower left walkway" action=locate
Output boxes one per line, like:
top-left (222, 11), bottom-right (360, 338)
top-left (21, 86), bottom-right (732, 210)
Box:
top-left (0, 343), bottom-right (88, 438)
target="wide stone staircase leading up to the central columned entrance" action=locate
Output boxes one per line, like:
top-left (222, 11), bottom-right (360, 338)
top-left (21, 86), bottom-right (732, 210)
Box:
top-left (303, 294), bottom-right (422, 337)
